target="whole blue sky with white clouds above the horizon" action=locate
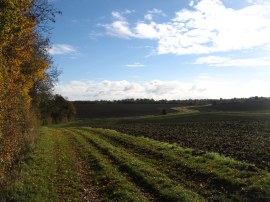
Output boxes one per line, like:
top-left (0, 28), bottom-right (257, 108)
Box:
top-left (49, 0), bottom-right (270, 100)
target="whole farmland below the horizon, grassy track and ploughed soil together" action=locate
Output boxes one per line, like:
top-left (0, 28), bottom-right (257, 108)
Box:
top-left (3, 101), bottom-right (270, 201)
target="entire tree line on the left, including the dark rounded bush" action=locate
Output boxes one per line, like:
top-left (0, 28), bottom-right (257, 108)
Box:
top-left (0, 0), bottom-right (75, 196)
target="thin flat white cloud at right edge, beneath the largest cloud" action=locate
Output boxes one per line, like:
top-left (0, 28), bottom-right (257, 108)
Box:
top-left (194, 56), bottom-right (270, 67)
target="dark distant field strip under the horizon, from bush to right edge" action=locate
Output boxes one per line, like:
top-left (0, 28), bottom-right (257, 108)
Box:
top-left (73, 100), bottom-right (270, 119)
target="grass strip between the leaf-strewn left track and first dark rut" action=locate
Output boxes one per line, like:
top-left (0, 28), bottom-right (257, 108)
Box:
top-left (67, 129), bottom-right (147, 201)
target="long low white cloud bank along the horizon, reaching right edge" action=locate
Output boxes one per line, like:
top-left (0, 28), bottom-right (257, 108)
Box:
top-left (55, 76), bottom-right (270, 100)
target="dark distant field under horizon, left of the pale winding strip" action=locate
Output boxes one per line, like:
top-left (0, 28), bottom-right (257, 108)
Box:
top-left (73, 102), bottom-right (179, 119)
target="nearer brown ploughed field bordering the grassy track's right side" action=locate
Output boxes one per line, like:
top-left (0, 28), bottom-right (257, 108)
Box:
top-left (70, 112), bottom-right (270, 170)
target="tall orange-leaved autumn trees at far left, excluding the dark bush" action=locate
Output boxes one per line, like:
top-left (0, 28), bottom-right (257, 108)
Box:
top-left (0, 0), bottom-right (58, 196)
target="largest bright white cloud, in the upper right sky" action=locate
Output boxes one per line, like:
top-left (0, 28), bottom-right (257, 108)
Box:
top-left (105, 0), bottom-right (270, 55)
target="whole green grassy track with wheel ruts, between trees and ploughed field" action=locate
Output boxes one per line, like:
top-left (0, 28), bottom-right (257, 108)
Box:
top-left (10, 127), bottom-right (270, 201)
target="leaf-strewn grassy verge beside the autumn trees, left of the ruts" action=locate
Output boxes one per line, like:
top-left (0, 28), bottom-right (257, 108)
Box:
top-left (9, 128), bottom-right (82, 202)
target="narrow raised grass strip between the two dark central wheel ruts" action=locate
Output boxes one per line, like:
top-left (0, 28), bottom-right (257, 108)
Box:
top-left (73, 129), bottom-right (202, 201)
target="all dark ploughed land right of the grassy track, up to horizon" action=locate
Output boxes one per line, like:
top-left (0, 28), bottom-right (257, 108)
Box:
top-left (70, 101), bottom-right (270, 170)
